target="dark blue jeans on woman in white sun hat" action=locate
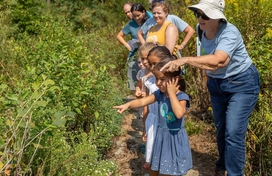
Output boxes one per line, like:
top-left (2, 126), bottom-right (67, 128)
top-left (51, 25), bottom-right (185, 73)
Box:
top-left (207, 65), bottom-right (260, 176)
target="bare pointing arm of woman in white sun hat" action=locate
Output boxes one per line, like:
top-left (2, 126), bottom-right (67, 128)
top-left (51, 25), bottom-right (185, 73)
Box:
top-left (161, 50), bottom-right (230, 72)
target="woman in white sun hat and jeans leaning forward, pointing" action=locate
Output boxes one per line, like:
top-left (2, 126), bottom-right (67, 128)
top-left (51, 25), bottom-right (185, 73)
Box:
top-left (161, 0), bottom-right (260, 176)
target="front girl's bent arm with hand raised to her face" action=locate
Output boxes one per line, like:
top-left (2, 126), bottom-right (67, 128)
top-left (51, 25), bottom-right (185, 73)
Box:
top-left (167, 78), bottom-right (187, 119)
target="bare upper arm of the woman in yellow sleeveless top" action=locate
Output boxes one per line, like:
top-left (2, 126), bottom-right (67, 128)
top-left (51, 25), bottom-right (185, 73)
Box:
top-left (165, 24), bottom-right (178, 53)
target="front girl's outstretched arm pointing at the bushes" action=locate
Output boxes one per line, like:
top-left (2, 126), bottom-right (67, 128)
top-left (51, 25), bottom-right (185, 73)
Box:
top-left (113, 94), bottom-right (156, 114)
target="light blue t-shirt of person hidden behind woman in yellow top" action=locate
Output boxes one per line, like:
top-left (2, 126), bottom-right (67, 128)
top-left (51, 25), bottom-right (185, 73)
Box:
top-left (141, 14), bottom-right (188, 35)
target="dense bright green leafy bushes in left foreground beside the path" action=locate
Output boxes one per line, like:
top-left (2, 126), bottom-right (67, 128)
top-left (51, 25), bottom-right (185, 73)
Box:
top-left (0, 1), bottom-right (123, 175)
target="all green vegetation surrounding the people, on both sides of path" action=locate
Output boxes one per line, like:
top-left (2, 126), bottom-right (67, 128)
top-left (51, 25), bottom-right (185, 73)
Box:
top-left (0, 0), bottom-right (272, 176)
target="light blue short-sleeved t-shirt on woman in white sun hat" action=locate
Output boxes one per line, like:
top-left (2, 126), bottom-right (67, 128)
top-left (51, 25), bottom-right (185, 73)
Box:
top-left (200, 22), bottom-right (252, 79)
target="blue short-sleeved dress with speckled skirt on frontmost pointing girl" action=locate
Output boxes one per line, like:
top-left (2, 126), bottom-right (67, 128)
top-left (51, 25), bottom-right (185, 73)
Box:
top-left (151, 90), bottom-right (193, 175)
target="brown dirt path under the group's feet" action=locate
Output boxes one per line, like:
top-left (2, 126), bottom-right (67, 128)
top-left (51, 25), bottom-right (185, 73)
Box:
top-left (108, 111), bottom-right (217, 176)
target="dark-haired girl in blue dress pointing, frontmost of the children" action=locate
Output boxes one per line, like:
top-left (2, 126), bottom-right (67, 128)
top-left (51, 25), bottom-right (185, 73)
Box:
top-left (113, 56), bottom-right (192, 176)
